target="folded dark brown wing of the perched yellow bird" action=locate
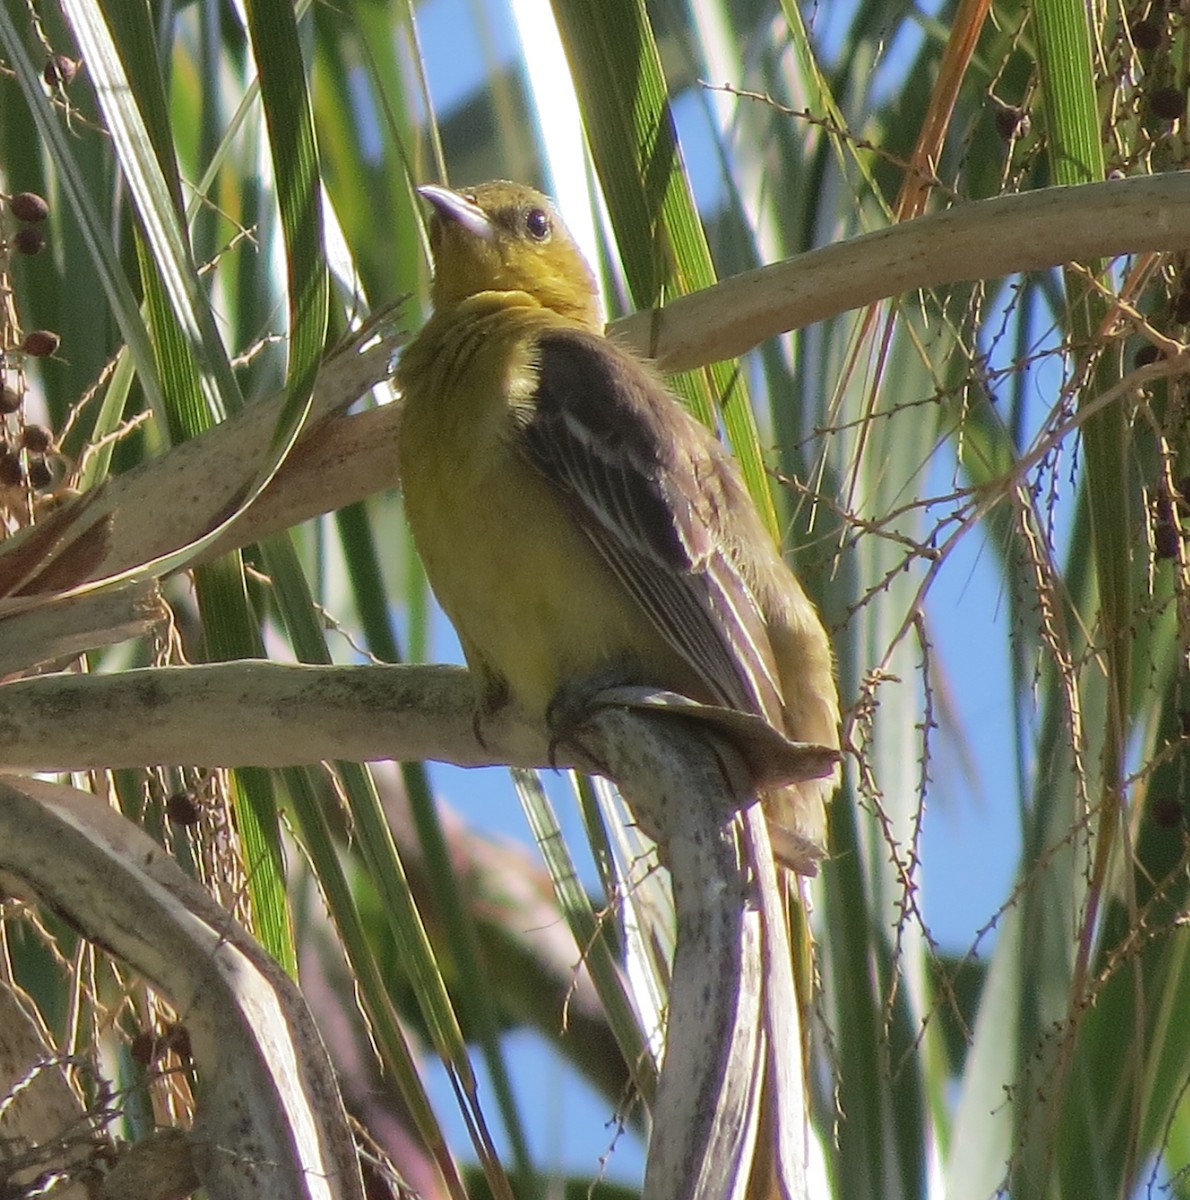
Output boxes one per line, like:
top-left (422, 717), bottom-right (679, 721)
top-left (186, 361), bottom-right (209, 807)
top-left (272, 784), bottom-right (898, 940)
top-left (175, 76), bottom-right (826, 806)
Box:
top-left (516, 328), bottom-right (782, 728)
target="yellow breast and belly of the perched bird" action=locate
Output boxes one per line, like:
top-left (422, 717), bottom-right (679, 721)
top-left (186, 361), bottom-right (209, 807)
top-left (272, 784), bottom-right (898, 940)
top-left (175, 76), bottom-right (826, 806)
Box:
top-left (398, 297), bottom-right (698, 720)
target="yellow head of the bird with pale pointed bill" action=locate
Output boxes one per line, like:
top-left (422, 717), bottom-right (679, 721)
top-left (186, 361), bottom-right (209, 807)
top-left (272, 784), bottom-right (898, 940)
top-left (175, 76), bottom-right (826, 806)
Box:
top-left (419, 180), bottom-right (602, 331)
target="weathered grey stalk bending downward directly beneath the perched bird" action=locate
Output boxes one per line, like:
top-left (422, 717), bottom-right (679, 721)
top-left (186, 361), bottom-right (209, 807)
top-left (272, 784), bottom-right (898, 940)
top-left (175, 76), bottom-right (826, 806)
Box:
top-left (584, 708), bottom-right (810, 1200)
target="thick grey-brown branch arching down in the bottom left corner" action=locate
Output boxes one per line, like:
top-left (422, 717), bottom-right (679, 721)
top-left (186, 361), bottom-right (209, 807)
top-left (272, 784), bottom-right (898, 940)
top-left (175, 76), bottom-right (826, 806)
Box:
top-left (0, 778), bottom-right (363, 1200)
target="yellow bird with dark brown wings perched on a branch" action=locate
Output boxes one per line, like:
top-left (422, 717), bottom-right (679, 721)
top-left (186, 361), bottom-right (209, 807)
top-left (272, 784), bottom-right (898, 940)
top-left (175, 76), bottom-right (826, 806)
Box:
top-left (396, 180), bottom-right (839, 875)
